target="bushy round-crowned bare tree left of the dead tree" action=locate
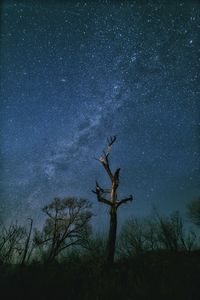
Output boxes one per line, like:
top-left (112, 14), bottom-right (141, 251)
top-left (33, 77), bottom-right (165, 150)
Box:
top-left (35, 197), bottom-right (92, 262)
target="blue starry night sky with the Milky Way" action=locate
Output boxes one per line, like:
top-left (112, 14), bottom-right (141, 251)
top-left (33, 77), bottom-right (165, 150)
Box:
top-left (0, 0), bottom-right (200, 226)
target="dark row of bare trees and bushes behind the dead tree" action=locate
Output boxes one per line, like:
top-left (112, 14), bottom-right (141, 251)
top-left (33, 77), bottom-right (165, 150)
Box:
top-left (0, 197), bottom-right (200, 265)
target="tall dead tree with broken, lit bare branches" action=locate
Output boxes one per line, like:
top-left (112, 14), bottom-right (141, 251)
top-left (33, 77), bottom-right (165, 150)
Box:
top-left (93, 136), bottom-right (133, 264)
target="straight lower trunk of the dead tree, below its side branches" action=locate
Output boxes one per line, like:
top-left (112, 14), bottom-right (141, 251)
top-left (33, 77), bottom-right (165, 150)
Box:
top-left (107, 207), bottom-right (117, 264)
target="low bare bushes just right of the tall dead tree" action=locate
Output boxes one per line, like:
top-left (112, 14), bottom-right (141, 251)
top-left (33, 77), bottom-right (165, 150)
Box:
top-left (118, 212), bottom-right (197, 257)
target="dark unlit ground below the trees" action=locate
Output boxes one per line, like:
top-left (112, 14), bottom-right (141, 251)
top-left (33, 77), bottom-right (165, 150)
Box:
top-left (0, 251), bottom-right (200, 300)
